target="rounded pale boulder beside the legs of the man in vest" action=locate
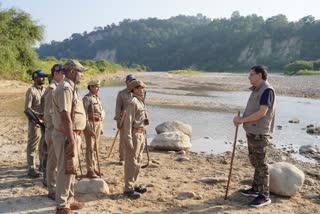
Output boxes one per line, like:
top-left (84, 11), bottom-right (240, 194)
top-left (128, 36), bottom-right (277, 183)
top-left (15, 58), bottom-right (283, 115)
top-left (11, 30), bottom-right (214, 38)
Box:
top-left (269, 162), bottom-right (305, 196)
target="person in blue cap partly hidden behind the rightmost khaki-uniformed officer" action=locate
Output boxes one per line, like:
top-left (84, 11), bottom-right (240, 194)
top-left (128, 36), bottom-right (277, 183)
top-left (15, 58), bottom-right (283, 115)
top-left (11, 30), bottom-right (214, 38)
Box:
top-left (114, 74), bottom-right (135, 165)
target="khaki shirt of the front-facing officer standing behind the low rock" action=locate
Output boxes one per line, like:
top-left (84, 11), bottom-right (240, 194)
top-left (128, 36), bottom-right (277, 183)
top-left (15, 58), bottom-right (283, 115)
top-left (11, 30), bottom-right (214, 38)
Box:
top-left (82, 92), bottom-right (106, 128)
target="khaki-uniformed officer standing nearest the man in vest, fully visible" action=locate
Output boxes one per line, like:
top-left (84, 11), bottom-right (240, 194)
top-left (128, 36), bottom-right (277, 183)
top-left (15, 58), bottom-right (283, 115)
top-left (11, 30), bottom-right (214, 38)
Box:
top-left (122, 80), bottom-right (149, 199)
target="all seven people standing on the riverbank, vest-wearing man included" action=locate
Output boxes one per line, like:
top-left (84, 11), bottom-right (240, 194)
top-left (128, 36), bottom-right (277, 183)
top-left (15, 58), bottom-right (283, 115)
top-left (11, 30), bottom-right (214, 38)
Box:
top-left (25, 60), bottom-right (275, 213)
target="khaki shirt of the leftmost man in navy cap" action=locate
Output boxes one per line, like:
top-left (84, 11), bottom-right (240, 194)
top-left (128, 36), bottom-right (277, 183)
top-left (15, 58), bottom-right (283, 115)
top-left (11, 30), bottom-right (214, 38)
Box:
top-left (24, 84), bottom-right (46, 115)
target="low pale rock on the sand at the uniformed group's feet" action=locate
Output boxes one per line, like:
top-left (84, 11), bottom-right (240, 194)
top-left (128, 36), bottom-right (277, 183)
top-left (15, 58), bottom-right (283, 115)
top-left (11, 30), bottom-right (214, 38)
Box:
top-left (74, 178), bottom-right (109, 194)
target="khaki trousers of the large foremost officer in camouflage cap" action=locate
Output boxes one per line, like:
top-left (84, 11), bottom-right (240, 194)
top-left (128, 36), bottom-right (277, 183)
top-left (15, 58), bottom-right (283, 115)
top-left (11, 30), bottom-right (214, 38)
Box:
top-left (52, 130), bottom-right (81, 209)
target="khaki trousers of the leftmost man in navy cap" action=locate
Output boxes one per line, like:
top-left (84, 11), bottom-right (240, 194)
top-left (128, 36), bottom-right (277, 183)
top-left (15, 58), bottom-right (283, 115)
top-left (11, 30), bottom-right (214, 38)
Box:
top-left (27, 121), bottom-right (41, 170)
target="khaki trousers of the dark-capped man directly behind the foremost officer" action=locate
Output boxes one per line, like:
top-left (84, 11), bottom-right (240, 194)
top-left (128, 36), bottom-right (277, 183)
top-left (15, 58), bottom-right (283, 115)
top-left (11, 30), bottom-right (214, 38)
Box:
top-left (45, 127), bottom-right (57, 193)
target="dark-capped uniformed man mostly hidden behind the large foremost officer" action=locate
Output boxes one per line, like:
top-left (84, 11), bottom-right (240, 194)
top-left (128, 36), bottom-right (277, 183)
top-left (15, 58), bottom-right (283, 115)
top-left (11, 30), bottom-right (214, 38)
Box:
top-left (42, 64), bottom-right (64, 200)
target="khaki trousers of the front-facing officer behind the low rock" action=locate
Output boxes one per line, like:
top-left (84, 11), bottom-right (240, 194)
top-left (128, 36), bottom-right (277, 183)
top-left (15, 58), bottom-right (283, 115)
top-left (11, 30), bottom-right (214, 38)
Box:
top-left (83, 121), bottom-right (102, 172)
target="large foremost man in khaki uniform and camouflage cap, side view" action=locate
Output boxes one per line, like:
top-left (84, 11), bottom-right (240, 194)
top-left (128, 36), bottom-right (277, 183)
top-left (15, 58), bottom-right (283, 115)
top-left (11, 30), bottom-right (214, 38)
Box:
top-left (52, 60), bottom-right (86, 214)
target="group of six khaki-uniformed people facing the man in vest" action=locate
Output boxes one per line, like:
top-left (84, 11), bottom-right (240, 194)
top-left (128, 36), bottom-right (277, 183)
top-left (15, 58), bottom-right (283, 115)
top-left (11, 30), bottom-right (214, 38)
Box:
top-left (25, 60), bottom-right (148, 214)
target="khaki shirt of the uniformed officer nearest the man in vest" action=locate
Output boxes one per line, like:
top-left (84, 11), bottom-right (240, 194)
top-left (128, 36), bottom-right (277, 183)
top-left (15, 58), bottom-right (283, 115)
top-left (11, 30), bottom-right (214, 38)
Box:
top-left (122, 95), bottom-right (148, 143)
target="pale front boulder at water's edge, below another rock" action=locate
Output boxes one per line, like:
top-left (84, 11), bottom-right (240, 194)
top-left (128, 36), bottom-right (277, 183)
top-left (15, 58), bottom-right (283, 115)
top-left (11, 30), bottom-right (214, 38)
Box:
top-left (150, 131), bottom-right (191, 151)
